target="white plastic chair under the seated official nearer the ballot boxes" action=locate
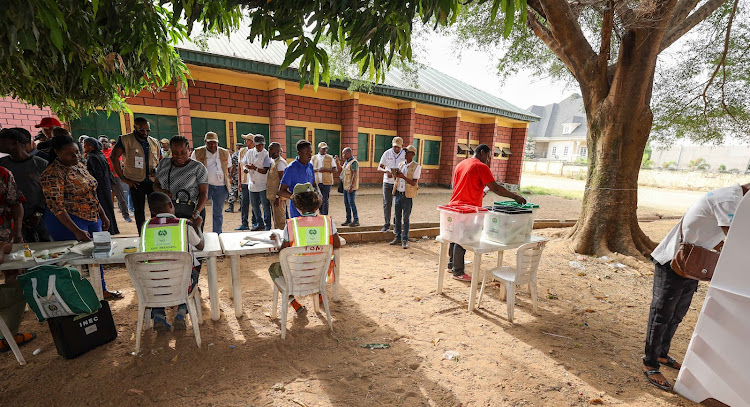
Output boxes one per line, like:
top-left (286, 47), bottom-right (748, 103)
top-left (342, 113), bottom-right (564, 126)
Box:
top-left (271, 245), bottom-right (333, 339)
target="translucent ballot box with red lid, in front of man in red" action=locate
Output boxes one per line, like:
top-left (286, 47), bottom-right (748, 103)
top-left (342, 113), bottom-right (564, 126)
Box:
top-left (438, 205), bottom-right (487, 244)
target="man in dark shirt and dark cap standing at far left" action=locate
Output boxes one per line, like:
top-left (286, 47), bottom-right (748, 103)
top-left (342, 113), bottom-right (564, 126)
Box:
top-left (0, 127), bottom-right (50, 243)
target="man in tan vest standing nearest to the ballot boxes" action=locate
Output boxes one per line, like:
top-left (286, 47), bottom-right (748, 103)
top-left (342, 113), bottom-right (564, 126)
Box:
top-left (390, 146), bottom-right (422, 249)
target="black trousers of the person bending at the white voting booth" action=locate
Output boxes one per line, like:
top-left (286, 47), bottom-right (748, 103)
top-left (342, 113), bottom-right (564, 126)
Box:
top-left (643, 263), bottom-right (698, 367)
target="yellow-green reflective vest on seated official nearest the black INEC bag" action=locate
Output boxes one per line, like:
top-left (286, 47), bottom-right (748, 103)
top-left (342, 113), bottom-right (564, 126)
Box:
top-left (141, 217), bottom-right (189, 252)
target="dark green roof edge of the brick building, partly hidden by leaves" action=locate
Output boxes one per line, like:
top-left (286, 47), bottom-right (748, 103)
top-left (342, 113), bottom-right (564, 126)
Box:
top-left (177, 48), bottom-right (540, 122)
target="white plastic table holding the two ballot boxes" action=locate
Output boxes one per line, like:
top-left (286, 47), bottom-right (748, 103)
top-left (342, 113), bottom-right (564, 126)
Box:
top-left (435, 235), bottom-right (547, 312)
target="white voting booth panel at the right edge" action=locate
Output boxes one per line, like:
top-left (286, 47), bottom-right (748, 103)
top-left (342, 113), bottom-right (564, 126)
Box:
top-left (674, 194), bottom-right (750, 407)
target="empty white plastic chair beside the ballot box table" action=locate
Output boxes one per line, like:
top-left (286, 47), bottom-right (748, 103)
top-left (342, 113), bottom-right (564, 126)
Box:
top-left (477, 242), bottom-right (546, 323)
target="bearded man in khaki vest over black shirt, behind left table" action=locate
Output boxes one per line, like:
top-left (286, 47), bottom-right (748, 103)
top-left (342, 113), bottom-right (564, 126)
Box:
top-left (109, 117), bottom-right (161, 234)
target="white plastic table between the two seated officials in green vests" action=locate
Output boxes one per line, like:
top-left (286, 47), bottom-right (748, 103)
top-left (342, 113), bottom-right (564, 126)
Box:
top-left (219, 229), bottom-right (346, 318)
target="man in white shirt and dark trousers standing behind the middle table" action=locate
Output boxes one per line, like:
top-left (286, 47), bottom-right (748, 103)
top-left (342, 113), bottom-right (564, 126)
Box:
top-left (242, 134), bottom-right (273, 230)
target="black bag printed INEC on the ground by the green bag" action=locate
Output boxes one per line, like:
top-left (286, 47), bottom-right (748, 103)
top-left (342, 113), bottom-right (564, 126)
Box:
top-left (47, 301), bottom-right (117, 359)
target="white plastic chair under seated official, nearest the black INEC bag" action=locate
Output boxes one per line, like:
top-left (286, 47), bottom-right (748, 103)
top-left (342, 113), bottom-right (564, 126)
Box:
top-left (125, 252), bottom-right (202, 354)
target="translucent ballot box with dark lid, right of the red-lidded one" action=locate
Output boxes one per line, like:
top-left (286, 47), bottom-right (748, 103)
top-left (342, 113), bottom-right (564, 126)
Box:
top-left (482, 206), bottom-right (534, 244)
